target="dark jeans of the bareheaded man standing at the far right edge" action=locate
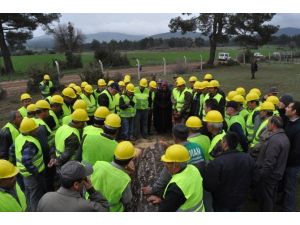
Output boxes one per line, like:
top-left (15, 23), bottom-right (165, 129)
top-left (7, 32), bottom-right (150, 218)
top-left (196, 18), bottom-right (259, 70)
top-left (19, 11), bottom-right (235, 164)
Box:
top-left (282, 166), bottom-right (300, 212)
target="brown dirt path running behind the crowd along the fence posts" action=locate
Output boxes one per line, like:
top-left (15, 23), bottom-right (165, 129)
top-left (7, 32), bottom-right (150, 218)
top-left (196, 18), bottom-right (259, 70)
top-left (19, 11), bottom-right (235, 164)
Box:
top-left (0, 63), bottom-right (199, 96)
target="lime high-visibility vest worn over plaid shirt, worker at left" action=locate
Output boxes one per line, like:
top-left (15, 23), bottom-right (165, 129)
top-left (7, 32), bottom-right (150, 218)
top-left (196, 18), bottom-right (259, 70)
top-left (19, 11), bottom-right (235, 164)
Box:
top-left (15, 134), bottom-right (45, 177)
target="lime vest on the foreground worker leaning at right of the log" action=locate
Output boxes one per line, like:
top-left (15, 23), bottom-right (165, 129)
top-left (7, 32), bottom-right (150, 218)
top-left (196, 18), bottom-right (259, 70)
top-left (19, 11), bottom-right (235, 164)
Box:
top-left (163, 164), bottom-right (205, 212)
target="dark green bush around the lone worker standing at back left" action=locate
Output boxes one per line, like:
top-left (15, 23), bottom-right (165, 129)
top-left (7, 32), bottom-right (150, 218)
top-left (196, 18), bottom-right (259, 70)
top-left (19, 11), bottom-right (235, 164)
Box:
top-left (27, 64), bottom-right (59, 93)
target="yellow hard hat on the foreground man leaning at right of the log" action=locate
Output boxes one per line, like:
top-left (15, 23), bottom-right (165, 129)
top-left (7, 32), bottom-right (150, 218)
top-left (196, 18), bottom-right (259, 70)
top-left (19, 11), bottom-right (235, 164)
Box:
top-left (161, 144), bottom-right (191, 163)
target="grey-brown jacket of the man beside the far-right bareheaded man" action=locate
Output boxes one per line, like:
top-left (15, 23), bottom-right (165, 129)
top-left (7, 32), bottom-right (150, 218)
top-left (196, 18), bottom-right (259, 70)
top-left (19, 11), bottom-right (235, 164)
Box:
top-left (255, 129), bottom-right (290, 181)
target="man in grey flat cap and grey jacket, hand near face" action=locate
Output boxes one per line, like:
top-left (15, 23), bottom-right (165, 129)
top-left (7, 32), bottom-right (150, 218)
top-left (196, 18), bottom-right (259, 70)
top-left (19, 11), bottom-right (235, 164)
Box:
top-left (37, 161), bottom-right (108, 212)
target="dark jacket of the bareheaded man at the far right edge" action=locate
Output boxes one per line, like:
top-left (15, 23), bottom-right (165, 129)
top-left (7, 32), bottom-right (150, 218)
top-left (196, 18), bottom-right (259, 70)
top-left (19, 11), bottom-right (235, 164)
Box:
top-left (285, 118), bottom-right (300, 166)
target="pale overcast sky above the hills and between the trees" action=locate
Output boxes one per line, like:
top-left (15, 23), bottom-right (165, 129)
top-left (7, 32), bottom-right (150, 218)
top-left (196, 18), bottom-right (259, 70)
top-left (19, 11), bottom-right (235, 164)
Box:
top-left (34, 13), bottom-right (300, 36)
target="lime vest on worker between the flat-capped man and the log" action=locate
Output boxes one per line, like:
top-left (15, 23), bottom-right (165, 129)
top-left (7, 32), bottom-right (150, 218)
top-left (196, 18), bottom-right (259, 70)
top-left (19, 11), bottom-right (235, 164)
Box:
top-left (91, 161), bottom-right (131, 212)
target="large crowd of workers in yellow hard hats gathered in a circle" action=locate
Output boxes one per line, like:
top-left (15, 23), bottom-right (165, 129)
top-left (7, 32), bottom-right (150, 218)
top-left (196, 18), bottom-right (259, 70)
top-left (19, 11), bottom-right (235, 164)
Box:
top-left (0, 74), bottom-right (300, 212)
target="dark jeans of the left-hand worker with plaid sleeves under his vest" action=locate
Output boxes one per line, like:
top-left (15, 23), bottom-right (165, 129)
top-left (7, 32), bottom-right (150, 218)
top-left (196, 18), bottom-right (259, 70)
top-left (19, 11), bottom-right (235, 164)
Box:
top-left (23, 172), bottom-right (46, 212)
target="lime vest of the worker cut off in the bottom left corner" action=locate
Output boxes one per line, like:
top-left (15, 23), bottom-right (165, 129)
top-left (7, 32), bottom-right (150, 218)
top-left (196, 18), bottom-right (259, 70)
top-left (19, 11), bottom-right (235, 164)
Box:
top-left (0, 183), bottom-right (27, 212)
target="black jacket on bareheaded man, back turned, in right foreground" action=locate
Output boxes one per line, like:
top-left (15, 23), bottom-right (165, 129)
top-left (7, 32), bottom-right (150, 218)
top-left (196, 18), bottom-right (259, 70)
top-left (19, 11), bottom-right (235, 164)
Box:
top-left (203, 150), bottom-right (255, 210)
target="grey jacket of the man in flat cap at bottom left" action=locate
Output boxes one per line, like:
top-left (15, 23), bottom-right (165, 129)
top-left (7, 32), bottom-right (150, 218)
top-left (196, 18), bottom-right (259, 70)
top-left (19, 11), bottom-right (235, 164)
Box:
top-left (37, 187), bottom-right (109, 212)
